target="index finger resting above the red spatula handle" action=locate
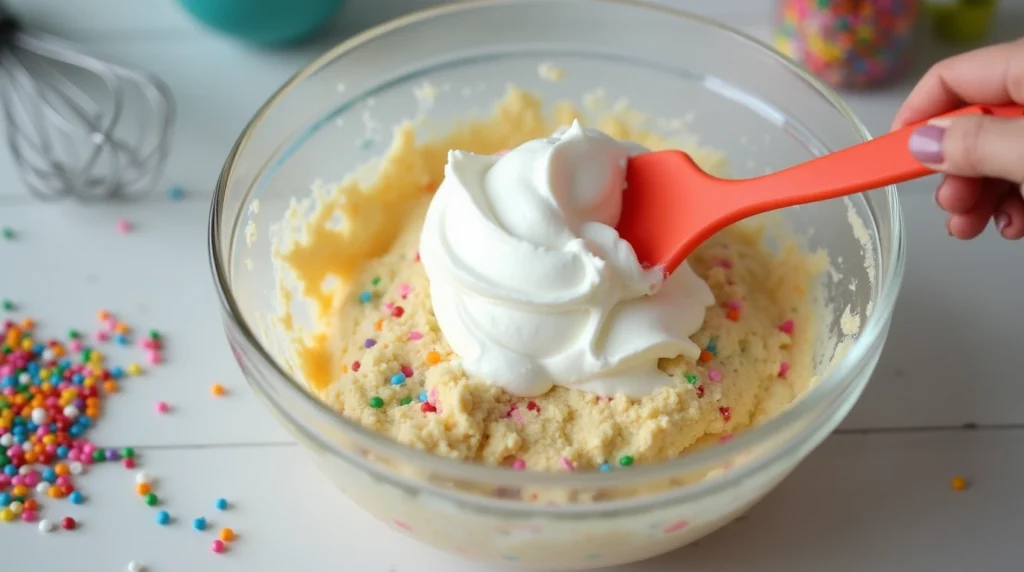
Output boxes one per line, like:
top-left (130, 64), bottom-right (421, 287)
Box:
top-left (892, 40), bottom-right (1024, 129)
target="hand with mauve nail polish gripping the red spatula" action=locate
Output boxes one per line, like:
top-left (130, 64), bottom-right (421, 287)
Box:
top-left (892, 39), bottom-right (1024, 239)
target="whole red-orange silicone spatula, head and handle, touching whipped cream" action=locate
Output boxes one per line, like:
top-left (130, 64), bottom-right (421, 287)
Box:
top-left (617, 105), bottom-right (1024, 274)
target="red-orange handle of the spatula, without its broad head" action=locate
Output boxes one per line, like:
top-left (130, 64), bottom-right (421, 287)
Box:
top-left (720, 105), bottom-right (1024, 216)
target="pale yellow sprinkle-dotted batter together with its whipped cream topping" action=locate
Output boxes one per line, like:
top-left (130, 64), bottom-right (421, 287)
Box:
top-left (269, 88), bottom-right (827, 487)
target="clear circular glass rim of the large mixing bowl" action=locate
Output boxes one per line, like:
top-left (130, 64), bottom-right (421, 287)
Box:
top-left (208, 0), bottom-right (905, 487)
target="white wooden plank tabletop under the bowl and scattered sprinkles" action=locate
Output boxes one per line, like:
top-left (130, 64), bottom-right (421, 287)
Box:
top-left (0, 0), bottom-right (1024, 572)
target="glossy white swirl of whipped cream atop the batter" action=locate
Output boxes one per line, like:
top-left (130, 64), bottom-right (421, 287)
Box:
top-left (420, 123), bottom-right (715, 397)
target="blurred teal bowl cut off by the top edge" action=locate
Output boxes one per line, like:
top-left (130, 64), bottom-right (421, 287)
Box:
top-left (178, 0), bottom-right (344, 46)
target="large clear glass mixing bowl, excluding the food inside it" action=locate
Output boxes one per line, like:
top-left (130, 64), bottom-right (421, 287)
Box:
top-left (210, 0), bottom-right (904, 570)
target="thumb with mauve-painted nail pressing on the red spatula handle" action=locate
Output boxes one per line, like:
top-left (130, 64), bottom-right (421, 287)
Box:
top-left (909, 116), bottom-right (1024, 183)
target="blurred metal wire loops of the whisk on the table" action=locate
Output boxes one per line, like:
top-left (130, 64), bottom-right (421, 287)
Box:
top-left (0, 8), bottom-right (174, 201)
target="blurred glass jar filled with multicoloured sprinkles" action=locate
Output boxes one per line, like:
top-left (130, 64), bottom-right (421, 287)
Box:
top-left (775, 0), bottom-right (920, 88)
